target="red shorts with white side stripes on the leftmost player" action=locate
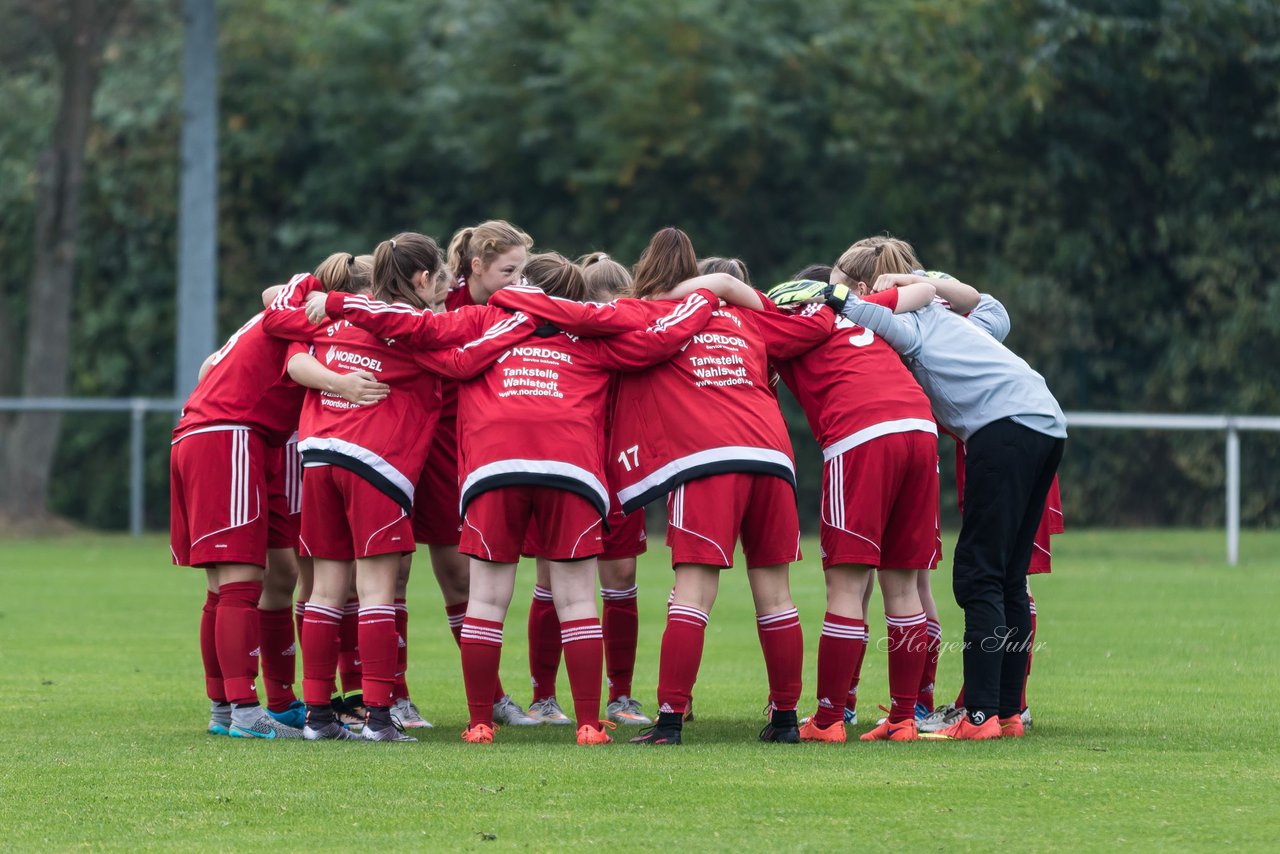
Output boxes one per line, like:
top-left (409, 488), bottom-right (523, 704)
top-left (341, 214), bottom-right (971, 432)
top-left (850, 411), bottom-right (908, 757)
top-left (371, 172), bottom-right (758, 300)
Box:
top-left (169, 428), bottom-right (268, 567)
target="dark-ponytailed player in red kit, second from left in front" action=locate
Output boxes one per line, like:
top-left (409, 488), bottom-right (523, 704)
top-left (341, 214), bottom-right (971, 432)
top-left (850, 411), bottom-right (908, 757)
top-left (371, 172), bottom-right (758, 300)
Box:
top-left (265, 234), bottom-right (531, 741)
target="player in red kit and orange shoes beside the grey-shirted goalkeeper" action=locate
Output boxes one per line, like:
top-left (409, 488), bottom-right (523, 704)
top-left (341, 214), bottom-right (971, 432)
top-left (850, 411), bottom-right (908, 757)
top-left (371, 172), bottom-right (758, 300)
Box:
top-left (757, 246), bottom-right (941, 741)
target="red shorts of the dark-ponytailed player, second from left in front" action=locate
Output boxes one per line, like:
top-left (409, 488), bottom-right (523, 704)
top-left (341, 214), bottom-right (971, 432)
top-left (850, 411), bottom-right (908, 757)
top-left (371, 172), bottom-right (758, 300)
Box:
top-left (298, 466), bottom-right (413, 561)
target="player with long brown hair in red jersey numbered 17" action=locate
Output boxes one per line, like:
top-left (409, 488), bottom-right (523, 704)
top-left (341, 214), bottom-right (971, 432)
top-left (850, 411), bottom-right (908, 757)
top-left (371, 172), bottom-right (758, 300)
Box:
top-left (493, 228), bottom-right (833, 744)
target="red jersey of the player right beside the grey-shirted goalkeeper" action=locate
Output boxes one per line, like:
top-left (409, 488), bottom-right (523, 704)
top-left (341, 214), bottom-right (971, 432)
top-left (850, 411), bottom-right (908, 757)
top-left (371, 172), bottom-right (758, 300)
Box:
top-left (765, 291), bottom-right (938, 460)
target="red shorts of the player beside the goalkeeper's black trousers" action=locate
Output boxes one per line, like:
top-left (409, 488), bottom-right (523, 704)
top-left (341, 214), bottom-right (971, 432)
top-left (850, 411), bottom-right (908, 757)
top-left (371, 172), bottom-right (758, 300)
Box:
top-left (819, 430), bottom-right (942, 570)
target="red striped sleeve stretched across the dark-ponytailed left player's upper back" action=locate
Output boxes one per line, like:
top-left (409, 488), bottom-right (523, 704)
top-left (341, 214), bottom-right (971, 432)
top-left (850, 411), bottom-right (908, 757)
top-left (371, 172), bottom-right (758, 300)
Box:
top-left (324, 291), bottom-right (507, 348)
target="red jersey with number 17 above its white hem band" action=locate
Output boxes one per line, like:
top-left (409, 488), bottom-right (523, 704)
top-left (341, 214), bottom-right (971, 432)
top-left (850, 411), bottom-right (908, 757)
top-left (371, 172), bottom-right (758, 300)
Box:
top-left (490, 286), bottom-right (835, 512)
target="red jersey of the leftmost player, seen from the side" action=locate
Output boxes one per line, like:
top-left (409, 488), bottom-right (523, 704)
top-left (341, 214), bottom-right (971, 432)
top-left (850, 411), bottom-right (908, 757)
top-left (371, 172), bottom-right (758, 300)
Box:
top-left (173, 274), bottom-right (314, 448)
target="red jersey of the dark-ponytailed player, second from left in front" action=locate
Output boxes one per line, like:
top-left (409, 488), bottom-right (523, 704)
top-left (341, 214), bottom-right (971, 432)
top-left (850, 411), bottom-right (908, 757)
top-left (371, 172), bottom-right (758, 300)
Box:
top-left (264, 278), bottom-right (532, 512)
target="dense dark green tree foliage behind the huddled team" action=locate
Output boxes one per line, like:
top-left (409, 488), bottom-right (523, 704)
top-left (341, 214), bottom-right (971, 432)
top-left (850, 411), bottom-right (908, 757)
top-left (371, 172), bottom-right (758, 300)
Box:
top-left (0, 0), bottom-right (1280, 525)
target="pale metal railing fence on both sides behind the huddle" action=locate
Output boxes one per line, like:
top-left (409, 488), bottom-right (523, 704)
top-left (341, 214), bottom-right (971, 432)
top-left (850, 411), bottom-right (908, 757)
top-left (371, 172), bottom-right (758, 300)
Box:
top-left (0, 397), bottom-right (1280, 566)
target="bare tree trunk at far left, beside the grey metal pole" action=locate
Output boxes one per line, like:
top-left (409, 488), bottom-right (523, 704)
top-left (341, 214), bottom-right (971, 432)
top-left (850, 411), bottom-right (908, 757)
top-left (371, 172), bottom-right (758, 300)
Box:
top-left (0, 0), bottom-right (124, 519)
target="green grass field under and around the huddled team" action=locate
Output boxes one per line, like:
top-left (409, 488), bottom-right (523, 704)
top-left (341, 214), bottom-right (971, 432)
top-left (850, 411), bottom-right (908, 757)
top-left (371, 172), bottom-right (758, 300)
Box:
top-left (0, 531), bottom-right (1280, 850)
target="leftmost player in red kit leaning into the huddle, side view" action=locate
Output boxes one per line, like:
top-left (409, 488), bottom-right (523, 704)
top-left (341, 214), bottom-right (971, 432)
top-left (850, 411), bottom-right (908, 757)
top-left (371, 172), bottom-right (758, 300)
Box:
top-left (170, 268), bottom-right (350, 739)
